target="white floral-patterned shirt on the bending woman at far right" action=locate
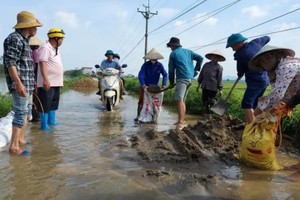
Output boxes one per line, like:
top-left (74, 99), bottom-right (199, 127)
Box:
top-left (257, 57), bottom-right (300, 111)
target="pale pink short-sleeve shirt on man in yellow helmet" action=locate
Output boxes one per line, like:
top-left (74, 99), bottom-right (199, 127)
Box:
top-left (37, 42), bottom-right (64, 87)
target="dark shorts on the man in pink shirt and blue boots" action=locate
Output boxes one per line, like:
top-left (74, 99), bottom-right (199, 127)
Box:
top-left (37, 87), bottom-right (60, 112)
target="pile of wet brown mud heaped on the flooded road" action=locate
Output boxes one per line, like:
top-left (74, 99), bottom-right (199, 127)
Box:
top-left (131, 115), bottom-right (244, 164)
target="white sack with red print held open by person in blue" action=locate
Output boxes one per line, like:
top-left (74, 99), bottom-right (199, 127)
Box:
top-left (138, 90), bottom-right (164, 123)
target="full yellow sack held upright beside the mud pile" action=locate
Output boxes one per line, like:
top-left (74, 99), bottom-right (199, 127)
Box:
top-left (240, 112), bottom-right (281, 170)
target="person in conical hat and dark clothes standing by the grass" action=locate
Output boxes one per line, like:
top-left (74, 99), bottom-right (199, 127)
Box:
top-left (197, 50), bottom-right (226, 113)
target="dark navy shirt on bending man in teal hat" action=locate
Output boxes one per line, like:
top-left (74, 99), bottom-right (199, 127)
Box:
top-left (234, 36), bottom-right (270, 88)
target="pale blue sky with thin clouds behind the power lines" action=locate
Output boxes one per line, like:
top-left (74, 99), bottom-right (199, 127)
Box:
top-left (0, 0), bottom-right (300, 78)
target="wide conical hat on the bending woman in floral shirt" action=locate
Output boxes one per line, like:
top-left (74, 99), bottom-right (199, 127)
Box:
top-left (249, 45), bottom-right (295, 71)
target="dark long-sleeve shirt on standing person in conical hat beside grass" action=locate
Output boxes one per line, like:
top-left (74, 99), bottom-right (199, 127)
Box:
top-left (198, 61), bottom-right (223, 91)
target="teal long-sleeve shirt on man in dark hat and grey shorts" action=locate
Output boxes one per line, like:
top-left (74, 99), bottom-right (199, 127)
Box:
top-left (169, 47), bottom-right (203, 85)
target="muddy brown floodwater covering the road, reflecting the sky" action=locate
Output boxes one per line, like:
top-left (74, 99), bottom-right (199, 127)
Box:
top-left (0, 91), bottom-right (300, 200)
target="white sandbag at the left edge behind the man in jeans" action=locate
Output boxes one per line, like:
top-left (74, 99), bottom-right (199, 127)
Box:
top-left (0, 111), bottom-right (14, 148)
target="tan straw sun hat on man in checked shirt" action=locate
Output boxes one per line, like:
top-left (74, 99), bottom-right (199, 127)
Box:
top-left (13, 11), bottom-right (43, 29)
